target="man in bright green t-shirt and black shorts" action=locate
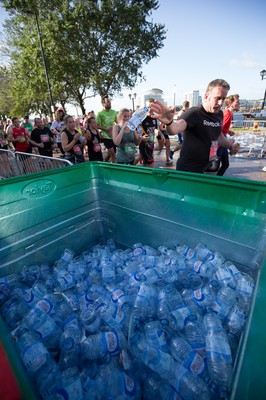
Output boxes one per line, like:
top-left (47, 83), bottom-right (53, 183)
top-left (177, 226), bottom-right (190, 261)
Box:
top-left (96, 96), bottom-right (117, 163)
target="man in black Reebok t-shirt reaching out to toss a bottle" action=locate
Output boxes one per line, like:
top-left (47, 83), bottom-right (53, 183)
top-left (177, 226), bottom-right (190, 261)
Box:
top-left (150, 79), bottom-right (239, 173)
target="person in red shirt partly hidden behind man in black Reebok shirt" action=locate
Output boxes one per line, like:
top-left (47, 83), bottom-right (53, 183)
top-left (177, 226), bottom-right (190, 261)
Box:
top-left (217, 94), bottom-right (239, 176)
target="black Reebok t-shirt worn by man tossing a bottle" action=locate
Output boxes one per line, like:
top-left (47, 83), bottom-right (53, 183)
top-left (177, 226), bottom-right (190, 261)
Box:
top-left (176, 106), bottom-right (223, 173)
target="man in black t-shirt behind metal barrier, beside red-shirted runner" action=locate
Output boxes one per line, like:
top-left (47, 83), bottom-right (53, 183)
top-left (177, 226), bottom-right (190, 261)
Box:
top-left (30, 118), bottom-right (55, 157)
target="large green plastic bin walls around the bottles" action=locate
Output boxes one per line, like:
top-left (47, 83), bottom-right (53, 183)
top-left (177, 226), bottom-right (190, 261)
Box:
top-left (0, 163), bottom-right (266, 400)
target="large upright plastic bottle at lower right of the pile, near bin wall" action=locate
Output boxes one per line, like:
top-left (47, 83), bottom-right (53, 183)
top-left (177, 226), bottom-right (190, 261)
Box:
top-left (203, 313), bottom-right (233, 397)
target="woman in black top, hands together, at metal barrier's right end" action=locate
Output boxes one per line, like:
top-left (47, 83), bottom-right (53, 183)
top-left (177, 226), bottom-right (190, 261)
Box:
top-left (61, 115), bottom-right (86, 164)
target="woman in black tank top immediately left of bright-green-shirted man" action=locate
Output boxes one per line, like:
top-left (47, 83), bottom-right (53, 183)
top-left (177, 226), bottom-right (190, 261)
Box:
top-left (84, 117), bottom-right (103, 161)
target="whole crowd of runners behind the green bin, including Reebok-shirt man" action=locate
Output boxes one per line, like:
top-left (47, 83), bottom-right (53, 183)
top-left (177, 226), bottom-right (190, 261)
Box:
top-left (0, 79), bottom-right (239, 175)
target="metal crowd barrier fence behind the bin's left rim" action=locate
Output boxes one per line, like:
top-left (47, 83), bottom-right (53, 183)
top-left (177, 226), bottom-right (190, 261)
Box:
top-left (0, 149), bottom-right (72, 179)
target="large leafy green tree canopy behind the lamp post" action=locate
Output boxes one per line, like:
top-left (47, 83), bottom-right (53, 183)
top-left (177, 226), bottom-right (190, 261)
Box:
top-left (2, 0), bottom-right (165, 113)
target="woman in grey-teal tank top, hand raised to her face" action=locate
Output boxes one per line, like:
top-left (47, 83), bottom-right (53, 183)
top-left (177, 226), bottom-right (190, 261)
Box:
top-left (113, 108), bottom-right (141, 165)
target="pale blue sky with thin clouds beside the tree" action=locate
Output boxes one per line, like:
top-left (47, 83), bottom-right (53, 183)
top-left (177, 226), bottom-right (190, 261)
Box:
top-left (0, 0), bottom-right (266, 114)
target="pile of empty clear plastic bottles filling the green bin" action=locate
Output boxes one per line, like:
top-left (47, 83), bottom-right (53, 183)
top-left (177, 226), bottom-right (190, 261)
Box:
top-left (0, 239), bottom-right (254, 400)
